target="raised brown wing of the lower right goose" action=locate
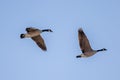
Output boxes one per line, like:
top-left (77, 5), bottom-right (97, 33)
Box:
top-left (78, 28), bottom-right (92, 53)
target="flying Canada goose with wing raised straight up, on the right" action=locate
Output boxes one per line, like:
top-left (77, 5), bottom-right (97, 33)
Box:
top-left (76, 28), bottom-right (107, 58)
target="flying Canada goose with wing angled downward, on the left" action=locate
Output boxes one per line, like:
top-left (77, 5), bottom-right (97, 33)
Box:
top-left (20, 27), bottom-right (53, 51)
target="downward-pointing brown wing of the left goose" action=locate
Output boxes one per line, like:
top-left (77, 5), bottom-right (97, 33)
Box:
top-left (32, 35), bottom-right (47, 51)
